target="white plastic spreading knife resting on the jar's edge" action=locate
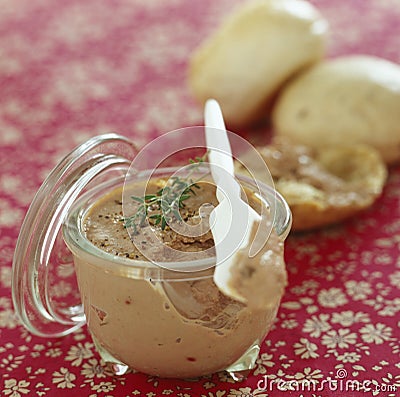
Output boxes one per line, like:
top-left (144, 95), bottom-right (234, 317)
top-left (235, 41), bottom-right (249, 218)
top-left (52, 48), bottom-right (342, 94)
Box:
top-left (204, 99), bottom-right (261, 302)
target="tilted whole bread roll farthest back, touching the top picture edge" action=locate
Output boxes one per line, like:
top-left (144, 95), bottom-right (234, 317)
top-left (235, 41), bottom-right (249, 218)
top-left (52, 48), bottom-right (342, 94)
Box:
top-left (189, 0), bottom-right (327, 126)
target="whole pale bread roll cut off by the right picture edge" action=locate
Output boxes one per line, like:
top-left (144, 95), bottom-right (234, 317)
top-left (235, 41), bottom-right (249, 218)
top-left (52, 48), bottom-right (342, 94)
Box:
top-left (272, 55), bottom-right (400, 164)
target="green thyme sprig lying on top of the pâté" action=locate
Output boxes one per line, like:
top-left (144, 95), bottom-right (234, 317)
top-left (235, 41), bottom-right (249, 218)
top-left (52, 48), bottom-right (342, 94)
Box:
top-left (123, 153), bottom-right (207, 234)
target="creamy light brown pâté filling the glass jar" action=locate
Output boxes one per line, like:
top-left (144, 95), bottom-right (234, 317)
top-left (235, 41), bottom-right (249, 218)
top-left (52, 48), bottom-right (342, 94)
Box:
top-left (75, 180), bottom-right (286, 378)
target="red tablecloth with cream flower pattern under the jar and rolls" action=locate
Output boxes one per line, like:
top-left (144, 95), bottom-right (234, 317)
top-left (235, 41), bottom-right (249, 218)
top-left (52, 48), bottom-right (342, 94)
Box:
top-left (0, 0), bottom-right (400, 397)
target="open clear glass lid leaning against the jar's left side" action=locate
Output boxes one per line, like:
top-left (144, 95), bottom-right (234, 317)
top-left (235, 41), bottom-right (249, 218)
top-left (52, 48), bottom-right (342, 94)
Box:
top-left (12, 133), bottom-right (137, 337)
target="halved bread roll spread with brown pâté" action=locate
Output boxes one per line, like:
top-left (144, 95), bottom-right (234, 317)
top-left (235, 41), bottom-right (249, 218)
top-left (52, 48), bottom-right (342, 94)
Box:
top-left (236, 140), bottom-right (387, 231)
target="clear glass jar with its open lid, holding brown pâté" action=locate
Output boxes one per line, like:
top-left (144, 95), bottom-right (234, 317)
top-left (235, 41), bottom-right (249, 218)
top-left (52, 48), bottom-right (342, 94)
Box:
top-left (12, 134), bottom-right (291, 379)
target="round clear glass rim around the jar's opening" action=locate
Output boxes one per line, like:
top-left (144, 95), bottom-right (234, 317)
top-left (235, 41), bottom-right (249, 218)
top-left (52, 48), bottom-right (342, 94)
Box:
top-left (63, 167), bottom-right (291, 281)
